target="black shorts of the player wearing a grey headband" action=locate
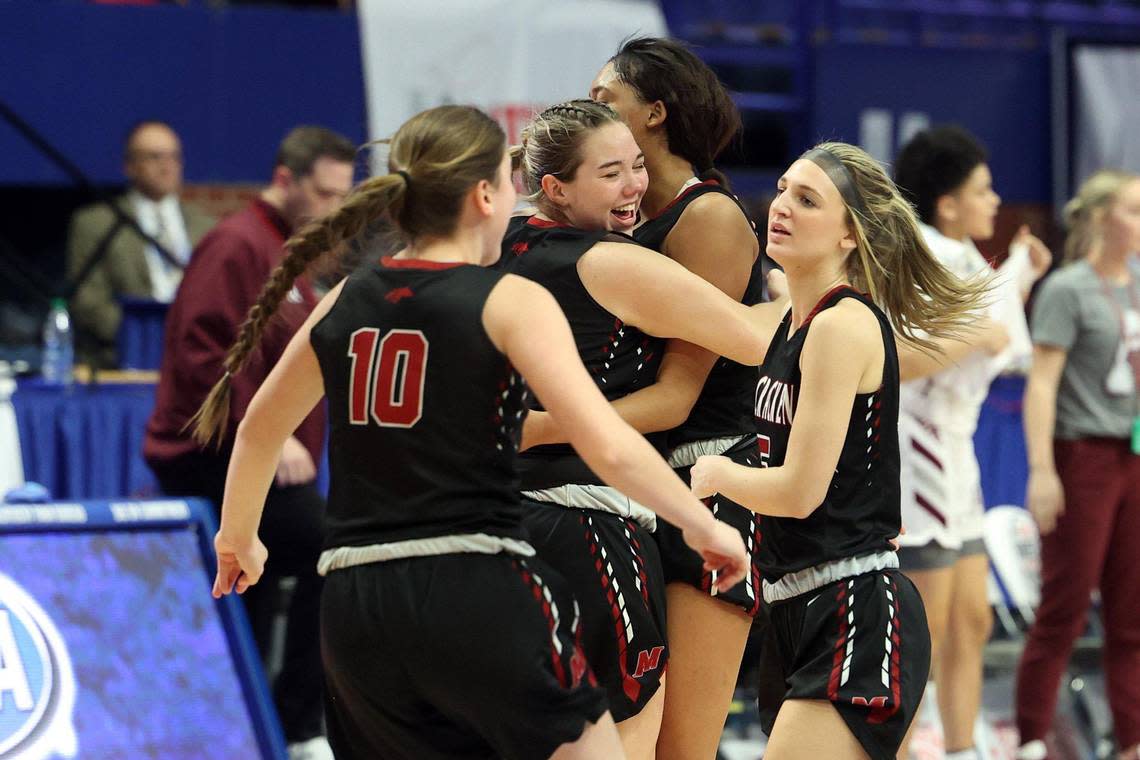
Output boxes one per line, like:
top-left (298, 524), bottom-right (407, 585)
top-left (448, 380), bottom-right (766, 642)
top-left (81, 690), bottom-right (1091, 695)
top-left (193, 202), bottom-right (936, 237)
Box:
top-left (759, 570), bottom-right (930, 760)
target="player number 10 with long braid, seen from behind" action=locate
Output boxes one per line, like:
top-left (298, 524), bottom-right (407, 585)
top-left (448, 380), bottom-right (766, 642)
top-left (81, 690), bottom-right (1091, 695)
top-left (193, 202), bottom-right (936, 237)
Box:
top-left (192, 106), bottom-right (744, 760)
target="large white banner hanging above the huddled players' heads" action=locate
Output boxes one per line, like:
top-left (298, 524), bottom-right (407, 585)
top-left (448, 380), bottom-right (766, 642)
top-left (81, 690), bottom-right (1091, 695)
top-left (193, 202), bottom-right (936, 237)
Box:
top-left (357, 0), bottom-right (666, 141)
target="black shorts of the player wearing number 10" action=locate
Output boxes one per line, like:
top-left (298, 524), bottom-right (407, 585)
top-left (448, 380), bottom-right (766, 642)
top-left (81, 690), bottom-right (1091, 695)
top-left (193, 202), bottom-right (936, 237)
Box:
top-left (320, 554), bottom-right (606, 760)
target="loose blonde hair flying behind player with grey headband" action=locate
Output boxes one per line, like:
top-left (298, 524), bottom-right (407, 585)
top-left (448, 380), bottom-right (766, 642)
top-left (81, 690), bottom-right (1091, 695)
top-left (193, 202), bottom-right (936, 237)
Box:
top-left (814, 142), bottom-right (985, 351)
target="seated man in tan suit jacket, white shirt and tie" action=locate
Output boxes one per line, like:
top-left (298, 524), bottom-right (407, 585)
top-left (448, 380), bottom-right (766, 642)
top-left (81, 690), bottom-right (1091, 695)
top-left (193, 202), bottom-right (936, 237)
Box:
top-left (67, 121), bottom-right (213, 367)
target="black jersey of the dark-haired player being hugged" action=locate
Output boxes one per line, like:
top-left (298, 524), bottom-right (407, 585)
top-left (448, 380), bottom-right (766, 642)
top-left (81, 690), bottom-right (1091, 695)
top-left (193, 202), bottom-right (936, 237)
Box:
top-left (634, 180), bottom-right (764, 447)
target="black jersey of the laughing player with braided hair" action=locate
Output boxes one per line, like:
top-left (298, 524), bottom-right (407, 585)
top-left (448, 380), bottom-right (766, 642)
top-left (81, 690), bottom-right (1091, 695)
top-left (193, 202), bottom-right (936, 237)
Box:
top-left (498, 216), bottom-right (665, 490)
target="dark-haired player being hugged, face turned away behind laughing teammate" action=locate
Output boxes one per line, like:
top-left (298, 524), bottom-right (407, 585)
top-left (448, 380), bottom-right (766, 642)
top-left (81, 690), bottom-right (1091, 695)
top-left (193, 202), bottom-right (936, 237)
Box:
top-left (591, 38), bottom-right (764, 760)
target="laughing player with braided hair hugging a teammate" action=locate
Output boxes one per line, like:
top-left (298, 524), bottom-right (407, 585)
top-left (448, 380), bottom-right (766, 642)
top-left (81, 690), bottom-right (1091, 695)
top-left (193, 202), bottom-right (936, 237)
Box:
top-left (502, 100), bottom-right (780, 757)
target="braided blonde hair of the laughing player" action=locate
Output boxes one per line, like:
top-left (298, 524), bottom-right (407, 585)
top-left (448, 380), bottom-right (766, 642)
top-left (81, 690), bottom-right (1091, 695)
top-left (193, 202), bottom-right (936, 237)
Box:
top-left (511, 99), bottom-right (621, 212)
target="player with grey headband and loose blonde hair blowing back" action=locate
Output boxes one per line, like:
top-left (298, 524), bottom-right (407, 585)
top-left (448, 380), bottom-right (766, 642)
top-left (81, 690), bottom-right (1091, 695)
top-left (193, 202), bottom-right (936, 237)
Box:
top-left (692, 142), bottom-right (980, 760)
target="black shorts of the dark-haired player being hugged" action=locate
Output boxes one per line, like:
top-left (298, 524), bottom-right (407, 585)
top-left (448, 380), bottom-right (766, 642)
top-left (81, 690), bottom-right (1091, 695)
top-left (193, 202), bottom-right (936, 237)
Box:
top-left (653, 435), bottom-right (760, 618)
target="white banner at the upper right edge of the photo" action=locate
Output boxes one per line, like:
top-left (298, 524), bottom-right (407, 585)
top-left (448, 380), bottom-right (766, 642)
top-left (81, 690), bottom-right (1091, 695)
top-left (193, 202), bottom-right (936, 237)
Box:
top-left (1072, 44), bottom-right (1140, 186)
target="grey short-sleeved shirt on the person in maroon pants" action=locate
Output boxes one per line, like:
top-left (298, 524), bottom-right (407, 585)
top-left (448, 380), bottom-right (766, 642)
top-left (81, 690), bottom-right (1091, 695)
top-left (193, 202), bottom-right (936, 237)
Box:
top-left (1032, 261), bottom-right (1140, 439)
